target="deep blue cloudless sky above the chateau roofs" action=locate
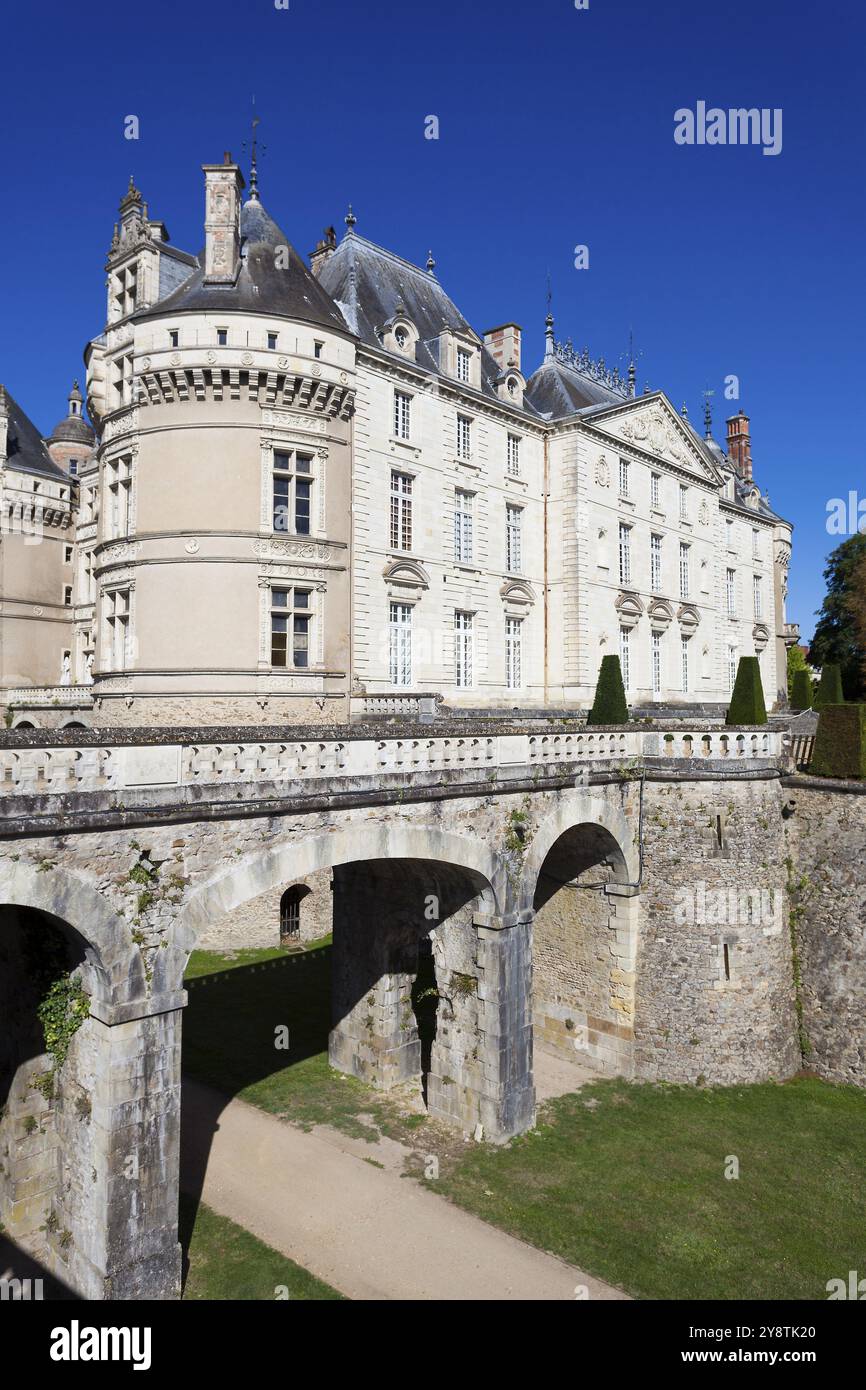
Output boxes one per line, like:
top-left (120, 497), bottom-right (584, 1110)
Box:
top-left (0, 0), bottom-right (866, 639)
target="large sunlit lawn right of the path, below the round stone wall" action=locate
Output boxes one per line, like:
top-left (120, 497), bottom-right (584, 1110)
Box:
top-left (431, 1077), bottom-right (866, 1300)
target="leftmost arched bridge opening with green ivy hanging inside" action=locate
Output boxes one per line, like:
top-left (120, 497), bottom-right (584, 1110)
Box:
top-left (0, 905), bottom-right (89, 1291)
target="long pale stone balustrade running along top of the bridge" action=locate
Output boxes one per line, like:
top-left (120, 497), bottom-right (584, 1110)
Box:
top-left (0, 722), bottom-right (783, 796)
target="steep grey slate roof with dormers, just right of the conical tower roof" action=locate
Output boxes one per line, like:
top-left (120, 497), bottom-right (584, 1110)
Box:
top-left (318, 231), bottom-right (537, 416)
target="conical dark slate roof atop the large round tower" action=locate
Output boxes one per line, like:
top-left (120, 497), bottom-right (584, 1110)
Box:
top-left (133, 199), bottom-right (346, 334)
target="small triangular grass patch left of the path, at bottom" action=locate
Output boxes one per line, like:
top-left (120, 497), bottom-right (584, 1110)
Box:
top-left (179, 1197), bottom-right (343, 1302)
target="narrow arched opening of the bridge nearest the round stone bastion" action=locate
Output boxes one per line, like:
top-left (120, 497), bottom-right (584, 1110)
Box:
top-left (532, 821), bottom-right (638, 1076)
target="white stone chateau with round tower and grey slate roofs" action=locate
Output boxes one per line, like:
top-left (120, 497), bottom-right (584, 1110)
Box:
top-left (0, 154), bottom-right (796, 727)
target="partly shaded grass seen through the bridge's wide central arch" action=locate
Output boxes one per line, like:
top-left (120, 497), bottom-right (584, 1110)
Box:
top-left (183, 937), bottom-right (427, 1143)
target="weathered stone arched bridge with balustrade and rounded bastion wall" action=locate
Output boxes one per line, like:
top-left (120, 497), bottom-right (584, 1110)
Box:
top-left (0, 719), bottom-right (799, 1298)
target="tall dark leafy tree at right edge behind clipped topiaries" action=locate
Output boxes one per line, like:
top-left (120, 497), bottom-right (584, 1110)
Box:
top-left (809, 531), bottom-right (866, 701)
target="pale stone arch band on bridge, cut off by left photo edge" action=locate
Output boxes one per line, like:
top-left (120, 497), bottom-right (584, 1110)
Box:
top-left (0, 859), bottom-right (145, 1019)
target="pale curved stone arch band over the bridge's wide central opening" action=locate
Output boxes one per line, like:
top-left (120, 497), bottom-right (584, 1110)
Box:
top-left (177, 821), bottom-right (506, 954)
